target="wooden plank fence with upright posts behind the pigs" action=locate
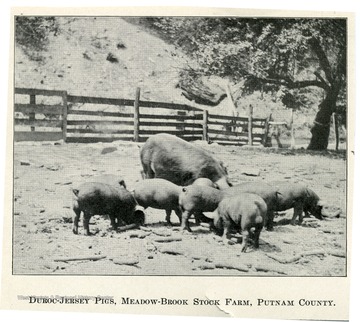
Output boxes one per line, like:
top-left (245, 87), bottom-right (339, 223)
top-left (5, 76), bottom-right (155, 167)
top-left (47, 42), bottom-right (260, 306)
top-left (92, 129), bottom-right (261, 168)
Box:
top-left (14, 88), bottom-right (269, 145)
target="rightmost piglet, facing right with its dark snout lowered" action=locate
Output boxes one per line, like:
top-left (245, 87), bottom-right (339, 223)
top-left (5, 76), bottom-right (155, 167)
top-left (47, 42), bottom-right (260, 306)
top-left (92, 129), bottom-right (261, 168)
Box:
top-left (271, 181), bottom-right (323, 225)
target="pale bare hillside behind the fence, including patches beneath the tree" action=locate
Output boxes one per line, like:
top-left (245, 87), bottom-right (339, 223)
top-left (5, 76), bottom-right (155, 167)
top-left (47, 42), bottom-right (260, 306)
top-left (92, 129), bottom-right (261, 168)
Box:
top-left (15, 17), bottom-right (344, 145)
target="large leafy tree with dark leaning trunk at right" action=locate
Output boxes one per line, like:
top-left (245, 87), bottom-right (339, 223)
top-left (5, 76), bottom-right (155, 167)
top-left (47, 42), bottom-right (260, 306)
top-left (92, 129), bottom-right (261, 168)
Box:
top-left (148, 18), bottom-right (347, 150)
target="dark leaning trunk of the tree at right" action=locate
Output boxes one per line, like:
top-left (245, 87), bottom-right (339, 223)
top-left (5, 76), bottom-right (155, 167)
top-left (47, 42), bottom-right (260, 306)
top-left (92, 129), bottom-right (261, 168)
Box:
top-left (307, 87), bottom-right (339, 151)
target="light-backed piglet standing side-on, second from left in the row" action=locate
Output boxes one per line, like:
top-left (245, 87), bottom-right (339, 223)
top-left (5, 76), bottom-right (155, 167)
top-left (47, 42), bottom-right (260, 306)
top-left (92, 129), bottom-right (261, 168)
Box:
top-left (133, 178), bottom-right (181, 224)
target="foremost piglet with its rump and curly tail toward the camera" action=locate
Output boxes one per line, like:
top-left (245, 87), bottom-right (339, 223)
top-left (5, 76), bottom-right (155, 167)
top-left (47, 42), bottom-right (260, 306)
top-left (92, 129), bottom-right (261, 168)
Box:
top-left (214, 193), bottom-right (267, 252)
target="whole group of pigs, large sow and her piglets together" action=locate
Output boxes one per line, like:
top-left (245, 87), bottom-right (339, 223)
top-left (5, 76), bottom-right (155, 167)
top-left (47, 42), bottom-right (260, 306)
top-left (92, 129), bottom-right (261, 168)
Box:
top-left (73, 133), bottom-right (322, 251)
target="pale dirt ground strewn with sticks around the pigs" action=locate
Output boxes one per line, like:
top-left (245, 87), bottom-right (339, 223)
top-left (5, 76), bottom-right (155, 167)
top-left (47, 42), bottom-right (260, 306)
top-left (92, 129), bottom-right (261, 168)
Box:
top-left (13, 141), bottom-right (347, 276)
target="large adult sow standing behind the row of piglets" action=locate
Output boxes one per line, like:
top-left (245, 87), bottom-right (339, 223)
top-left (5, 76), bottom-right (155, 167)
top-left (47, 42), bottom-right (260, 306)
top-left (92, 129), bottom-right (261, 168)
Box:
top-left (140, 133), bottom-right (230, 189)
